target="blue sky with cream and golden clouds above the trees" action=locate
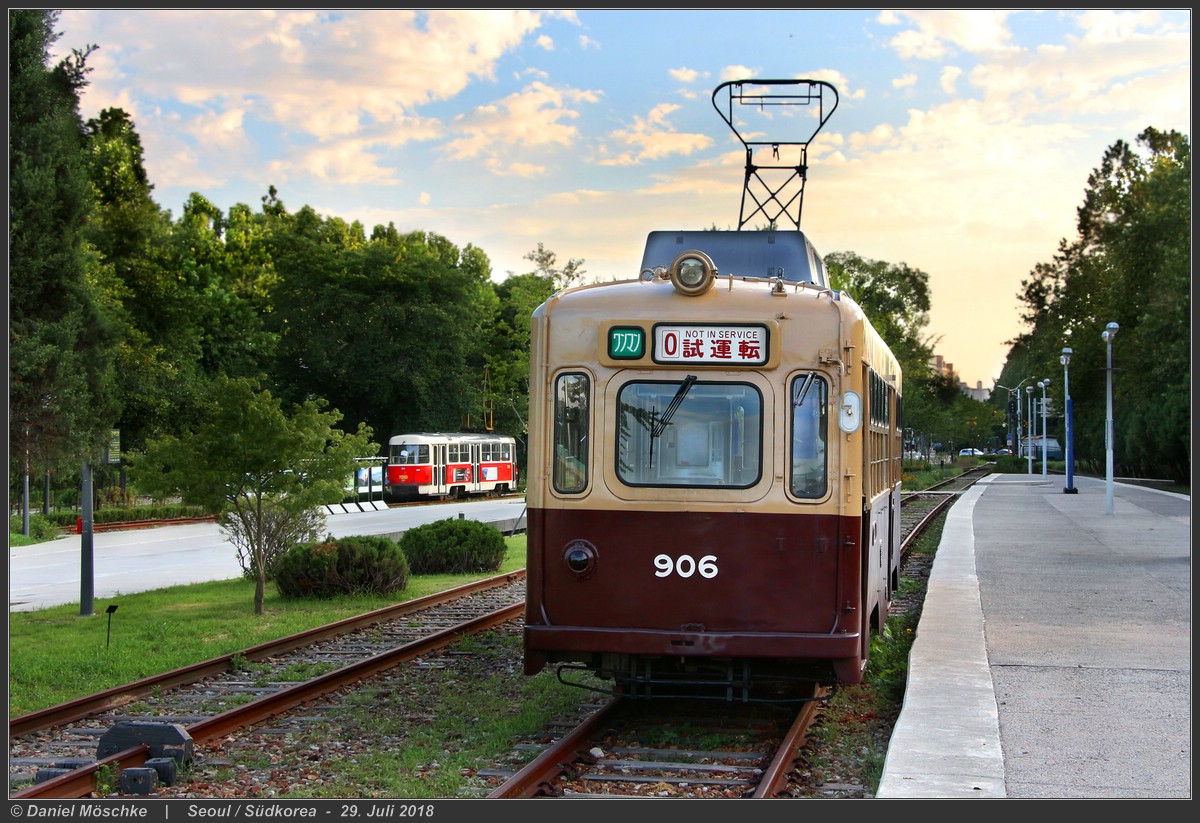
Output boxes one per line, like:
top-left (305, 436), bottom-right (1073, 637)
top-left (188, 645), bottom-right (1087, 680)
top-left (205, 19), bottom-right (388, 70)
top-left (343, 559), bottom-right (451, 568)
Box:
top-left (52, 8), bottom-right (1192, 389)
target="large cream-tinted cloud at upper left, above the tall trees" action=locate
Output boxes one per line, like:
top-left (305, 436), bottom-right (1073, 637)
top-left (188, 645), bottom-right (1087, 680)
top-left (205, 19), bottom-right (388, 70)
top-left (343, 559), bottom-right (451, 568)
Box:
top-left (60, 10), bottom-right (549, 185)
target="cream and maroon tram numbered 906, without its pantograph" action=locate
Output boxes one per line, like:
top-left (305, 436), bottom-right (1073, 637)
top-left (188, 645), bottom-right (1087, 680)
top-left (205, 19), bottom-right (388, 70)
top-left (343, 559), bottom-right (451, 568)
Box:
top-left (524, 230), bottom-right (902, 699)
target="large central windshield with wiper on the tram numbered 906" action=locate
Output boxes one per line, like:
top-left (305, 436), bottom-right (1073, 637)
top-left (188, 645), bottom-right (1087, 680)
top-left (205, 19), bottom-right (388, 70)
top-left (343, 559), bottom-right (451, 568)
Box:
top-left (617, 374), bottom-right (762, 488)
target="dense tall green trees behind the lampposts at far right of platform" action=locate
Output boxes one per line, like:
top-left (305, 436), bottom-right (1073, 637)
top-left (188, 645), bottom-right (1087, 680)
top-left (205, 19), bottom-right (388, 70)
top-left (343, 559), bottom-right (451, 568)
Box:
top-left (992, 128), bottom-right (1192, 482)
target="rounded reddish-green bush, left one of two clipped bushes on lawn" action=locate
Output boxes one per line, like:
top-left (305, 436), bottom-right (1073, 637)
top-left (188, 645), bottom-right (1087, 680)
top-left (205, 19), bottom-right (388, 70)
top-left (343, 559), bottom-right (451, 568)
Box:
top-left (274, 535), bottom-right (409, 597)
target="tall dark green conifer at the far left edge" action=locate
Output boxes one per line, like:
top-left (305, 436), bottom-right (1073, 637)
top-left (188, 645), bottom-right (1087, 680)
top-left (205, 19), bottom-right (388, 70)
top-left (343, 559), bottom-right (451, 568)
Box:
top-left (8, 8), bottom-right (120, 527)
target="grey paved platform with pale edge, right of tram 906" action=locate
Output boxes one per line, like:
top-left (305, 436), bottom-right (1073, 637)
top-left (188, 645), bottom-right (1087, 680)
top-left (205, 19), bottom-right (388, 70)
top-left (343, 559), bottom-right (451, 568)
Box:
top-left (876, 475), bottom-right (1192, 798)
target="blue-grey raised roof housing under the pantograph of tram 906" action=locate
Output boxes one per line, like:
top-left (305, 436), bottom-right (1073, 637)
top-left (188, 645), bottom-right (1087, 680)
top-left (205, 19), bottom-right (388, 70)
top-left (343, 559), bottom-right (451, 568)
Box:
top-left (642, 230), bottom-right (829, 288)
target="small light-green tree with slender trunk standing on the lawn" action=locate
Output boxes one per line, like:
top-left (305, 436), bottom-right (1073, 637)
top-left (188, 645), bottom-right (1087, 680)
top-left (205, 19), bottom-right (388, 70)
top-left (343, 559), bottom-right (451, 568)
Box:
top-left (130, 378), bottom-right (378, 614)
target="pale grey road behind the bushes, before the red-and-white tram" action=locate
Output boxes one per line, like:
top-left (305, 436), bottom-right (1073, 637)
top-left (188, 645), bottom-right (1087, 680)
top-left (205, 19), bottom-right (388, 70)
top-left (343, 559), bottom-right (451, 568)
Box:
top-left (8, 498), bottom-right (524, 613)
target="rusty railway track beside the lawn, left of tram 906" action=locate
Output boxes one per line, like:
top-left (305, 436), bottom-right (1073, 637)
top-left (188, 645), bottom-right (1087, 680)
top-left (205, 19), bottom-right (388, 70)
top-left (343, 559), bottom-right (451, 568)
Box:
top-left (8, 572), bottom-right (524, 798)
